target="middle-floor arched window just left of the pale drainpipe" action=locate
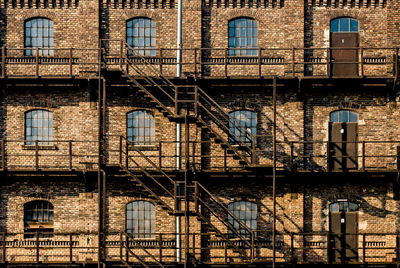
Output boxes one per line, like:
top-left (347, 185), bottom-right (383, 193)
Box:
top-left (126, 110), bottom-right (155, 145)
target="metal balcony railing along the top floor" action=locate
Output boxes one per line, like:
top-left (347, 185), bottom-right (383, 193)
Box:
top-left (0, 45), bottom-right (399, 78)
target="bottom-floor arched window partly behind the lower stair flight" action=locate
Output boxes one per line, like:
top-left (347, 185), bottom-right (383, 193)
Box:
top-left (228, 201), bottom-right (258, 237)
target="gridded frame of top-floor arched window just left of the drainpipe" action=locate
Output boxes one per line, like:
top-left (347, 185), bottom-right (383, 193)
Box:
top-left (125, 17), bottom-right (157, 57)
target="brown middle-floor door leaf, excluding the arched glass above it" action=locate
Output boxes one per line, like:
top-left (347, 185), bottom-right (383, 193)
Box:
top-left (328, 123), bottom-right (358, 171)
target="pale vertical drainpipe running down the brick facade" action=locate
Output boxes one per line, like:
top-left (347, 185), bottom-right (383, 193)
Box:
top-left (175, 0), bottom-right (182, 262)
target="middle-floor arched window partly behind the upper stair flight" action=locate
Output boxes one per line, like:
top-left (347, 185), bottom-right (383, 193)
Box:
top-left (229, 110), bottom-right (257, 146)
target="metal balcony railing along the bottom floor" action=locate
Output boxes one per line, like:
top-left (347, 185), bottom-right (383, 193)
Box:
top-left (0, 230), bottom-right (400, 265)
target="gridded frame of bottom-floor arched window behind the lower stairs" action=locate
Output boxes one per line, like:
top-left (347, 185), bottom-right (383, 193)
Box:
top-left (228, 200), bottom-right (259, 238)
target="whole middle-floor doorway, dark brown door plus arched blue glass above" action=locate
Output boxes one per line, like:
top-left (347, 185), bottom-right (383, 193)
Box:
top-left (328, 110), bottom-right (358, 171)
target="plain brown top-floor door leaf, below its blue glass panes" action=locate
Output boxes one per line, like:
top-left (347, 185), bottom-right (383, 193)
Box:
top-left (331, 33), bottom-right (358, 77)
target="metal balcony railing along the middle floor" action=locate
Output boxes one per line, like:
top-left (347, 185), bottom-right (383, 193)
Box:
top-left (0, 138), bottom-right (400, 172)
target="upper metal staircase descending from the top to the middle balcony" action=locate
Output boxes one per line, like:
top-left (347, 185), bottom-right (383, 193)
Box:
top-left (112, 44), bottom-right (256, 166)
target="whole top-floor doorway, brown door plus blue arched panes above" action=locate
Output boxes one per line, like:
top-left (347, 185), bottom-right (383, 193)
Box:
top-left (331, 18), bottom-right (359, 77)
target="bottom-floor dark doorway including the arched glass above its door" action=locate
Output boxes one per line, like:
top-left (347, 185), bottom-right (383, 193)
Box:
top-left (328, 201), bottom-right (358, 263)
